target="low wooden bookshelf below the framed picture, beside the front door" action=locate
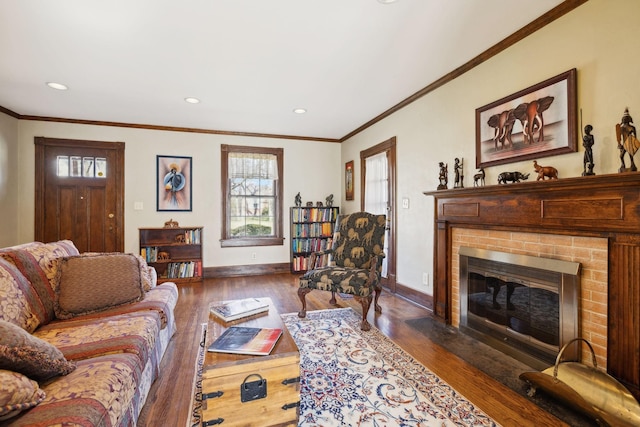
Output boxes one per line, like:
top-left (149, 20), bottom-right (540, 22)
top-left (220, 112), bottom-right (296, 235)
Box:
top-left (138, 227), bottom-right (203, 284)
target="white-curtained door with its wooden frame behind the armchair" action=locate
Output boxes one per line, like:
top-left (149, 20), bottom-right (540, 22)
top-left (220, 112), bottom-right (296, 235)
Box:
top-left (360, 137), bottom-right (396, 293)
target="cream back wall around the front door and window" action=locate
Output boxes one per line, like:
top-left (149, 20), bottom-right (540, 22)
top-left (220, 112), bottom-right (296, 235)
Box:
top-left (11, 120), bottom-right (340, 267)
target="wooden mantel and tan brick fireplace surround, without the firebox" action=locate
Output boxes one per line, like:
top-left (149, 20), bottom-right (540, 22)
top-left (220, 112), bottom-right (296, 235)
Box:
top-left (424, 173), bottom-right (640, 398)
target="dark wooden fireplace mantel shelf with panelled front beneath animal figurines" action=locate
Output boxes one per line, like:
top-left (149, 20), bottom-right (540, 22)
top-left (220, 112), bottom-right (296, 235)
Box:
top-left (424, 173), bottom-right (640, 235)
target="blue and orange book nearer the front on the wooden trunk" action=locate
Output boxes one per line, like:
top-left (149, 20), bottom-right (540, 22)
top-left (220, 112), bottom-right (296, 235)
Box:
top-left (207, 326), bottom-right (282, 356)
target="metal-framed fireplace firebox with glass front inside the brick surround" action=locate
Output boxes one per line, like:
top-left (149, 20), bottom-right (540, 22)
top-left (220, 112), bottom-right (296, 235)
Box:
top-left (459, 247), bottom-right (580, 369)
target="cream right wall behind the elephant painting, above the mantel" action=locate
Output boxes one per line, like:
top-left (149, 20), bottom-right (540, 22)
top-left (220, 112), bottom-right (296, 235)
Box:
top-left (342, 0), bottom-right (640, 292)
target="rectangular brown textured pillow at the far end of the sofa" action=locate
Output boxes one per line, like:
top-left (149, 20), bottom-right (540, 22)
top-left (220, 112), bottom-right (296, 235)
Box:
top-left (54, 253), bottom-right (144, 319)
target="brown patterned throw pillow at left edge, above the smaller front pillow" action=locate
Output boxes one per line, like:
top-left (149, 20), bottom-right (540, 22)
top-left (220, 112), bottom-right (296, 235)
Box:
top-left (0, 320), bottom-right (76, 381)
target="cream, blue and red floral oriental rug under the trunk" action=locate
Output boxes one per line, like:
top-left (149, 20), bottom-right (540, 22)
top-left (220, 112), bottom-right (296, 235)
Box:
top-left (188, 308), bottom-right (498, 427)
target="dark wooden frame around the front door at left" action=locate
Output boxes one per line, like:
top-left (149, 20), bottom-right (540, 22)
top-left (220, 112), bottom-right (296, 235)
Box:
top-left (34, 136), bottom-right (124, 252)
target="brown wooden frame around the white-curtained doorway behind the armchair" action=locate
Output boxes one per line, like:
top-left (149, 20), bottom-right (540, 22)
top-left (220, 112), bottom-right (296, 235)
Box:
top-left (360, 136), bottom-right (397, 293)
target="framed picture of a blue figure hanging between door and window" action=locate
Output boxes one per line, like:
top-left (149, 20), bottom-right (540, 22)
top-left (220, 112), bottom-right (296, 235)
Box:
top-left (156, 155), bottom-right (192, 212)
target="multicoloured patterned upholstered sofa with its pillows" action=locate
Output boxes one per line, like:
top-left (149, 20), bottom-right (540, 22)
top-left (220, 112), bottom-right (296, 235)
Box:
top-left (0, 240), bottom-right (178, 426)
